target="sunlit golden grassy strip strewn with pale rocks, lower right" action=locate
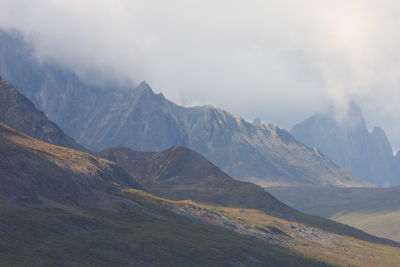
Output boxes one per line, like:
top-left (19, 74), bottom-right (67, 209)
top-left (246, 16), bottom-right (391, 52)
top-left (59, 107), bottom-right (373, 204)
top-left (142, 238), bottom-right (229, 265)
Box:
top-left (122, 190), bottom-right (400, 267)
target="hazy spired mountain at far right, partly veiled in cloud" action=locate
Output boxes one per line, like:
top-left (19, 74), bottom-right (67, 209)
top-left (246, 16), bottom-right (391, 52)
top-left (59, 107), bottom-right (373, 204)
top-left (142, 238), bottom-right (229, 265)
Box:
top-left (291, 102), bottom-right (400, 186)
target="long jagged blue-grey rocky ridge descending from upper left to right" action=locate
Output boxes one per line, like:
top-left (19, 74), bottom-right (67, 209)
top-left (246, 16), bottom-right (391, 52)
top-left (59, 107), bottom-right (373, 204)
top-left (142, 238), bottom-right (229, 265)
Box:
top-left (0, 29), bottom-right (366, 186)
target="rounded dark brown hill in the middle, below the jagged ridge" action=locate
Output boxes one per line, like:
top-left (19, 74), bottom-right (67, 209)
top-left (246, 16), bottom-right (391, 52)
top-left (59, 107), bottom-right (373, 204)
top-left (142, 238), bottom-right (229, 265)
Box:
top-left (98, 147), bottom-right (294, 216)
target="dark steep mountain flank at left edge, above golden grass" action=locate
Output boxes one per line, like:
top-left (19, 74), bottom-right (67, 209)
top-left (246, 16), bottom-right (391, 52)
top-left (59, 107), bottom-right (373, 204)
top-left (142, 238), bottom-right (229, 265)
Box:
top-left (0, 77), bottom-right (84, 150)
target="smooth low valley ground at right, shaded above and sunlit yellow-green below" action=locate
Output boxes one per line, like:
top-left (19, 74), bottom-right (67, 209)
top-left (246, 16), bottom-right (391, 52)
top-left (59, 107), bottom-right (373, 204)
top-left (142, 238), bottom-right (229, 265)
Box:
top-left (268, 187), bottom-right (400, 242)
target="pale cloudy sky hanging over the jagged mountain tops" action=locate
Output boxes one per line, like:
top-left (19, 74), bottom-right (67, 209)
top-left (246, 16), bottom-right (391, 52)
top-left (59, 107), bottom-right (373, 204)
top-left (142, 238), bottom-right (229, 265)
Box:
top-left (0, 0), bottom-right (400, 149)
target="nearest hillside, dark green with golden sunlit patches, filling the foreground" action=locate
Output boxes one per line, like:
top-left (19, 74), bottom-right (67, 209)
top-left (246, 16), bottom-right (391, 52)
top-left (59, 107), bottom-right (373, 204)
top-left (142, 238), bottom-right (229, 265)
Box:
top-left (0, 124), bottom-right (400, 266)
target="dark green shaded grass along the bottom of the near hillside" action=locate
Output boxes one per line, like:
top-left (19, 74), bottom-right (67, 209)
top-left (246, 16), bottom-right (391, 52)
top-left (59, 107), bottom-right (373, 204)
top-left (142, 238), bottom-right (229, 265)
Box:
top-left (0, 206), bottom-right (325, 266)
